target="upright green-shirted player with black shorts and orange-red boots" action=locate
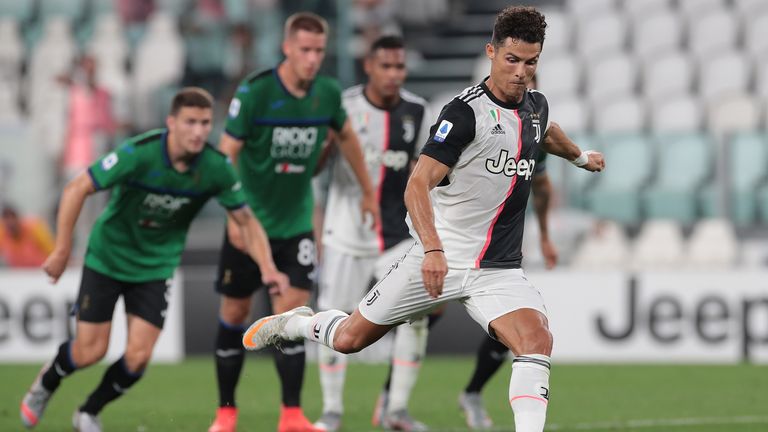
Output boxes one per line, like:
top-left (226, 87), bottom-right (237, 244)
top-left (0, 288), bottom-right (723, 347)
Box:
top-left (209, 13), bottom-right (378, 432)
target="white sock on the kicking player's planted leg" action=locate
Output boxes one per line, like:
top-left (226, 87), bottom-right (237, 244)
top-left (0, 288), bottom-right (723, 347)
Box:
top-left (509, 354), bottom-right (549, 432)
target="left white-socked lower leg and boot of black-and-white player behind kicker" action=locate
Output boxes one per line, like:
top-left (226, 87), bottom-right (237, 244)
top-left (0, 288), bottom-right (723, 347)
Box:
top-left (315, 345), bottom-right (347, 432)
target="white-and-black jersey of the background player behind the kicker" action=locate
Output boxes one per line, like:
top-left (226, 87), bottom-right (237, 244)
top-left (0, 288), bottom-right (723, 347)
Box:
top-left (323, 85), bottom-right (433, 256)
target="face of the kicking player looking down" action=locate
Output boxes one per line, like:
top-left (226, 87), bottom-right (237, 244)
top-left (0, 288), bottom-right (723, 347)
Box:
top-left (485, 38), bottom-right (541, 102)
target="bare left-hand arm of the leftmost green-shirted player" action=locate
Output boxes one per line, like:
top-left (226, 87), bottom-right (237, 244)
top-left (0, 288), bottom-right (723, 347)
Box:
top-left (43, 172), bottom-right (96, 283)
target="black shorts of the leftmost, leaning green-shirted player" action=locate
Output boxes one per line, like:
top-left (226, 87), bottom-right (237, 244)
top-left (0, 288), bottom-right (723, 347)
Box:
top-left (74, 266), bottom-right (171, 329)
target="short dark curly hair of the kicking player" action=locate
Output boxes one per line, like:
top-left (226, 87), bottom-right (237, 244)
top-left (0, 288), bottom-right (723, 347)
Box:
top-left (491, 6), bottom-right (547, 47)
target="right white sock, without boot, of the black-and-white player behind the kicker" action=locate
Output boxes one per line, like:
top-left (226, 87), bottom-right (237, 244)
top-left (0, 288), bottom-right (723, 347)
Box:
top-left (387, 317), bottom-right (429, 413)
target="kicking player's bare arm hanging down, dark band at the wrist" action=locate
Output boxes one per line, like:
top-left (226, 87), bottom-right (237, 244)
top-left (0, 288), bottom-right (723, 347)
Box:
top-left (405, 155), bottom-right (450, 298)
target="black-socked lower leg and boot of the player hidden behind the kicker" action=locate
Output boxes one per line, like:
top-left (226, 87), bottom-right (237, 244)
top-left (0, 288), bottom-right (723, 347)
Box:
top-left (459, 337), bottom-right (509, 430)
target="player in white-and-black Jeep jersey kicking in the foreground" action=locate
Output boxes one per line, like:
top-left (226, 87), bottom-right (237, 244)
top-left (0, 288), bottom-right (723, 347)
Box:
top-left (243, 7), bottom-right (604, 432)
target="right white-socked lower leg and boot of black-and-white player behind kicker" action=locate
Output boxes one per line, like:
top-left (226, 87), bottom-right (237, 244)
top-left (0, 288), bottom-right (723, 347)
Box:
top-left (382, 317), bottom-right (429, 431)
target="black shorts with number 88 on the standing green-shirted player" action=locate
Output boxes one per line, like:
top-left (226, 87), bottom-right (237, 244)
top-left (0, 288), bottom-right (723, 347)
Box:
top-left (215, 230), bottom-right (315, 298)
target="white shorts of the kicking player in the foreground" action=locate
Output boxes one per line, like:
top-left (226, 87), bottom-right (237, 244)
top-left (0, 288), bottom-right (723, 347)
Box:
top-left (358, 245), bottom-right (547, 332)
